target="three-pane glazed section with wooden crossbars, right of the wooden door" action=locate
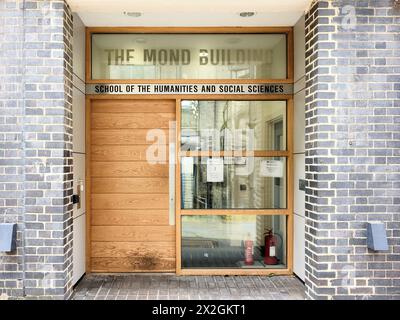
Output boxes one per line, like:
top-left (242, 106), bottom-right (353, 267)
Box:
top-left (177, 100), bottom-right (291, 274)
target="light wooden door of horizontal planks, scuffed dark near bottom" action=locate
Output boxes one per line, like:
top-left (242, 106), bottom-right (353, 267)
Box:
top-left (89, 99), bottom-right (175, 272)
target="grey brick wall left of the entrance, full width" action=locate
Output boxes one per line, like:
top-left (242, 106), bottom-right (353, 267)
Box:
top-left (0, 0), bottom-right (72, 299)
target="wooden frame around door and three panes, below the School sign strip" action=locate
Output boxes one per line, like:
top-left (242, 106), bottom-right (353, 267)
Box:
top-left (85, 95), bottom-right (294, 275)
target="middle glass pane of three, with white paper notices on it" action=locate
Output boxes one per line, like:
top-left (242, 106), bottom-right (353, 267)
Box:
top-left (181, 157), bottom-right (286, 209)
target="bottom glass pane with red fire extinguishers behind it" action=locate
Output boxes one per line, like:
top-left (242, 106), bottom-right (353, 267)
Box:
top-left (182, 215), bottom-right (286, 269)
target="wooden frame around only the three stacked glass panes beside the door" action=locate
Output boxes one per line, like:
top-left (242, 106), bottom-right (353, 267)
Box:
top-left (175, 95), bottom-right (294, 275)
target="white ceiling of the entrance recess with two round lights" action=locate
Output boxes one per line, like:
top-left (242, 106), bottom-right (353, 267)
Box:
top-left (67, 0), bottom-right (311, 27)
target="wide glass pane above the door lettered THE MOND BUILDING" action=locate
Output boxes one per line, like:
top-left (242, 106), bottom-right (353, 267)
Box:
top-left (92, 34), bottom-right (287, 79)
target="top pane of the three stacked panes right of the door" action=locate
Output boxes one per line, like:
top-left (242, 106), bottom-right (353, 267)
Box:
top-left (181, 100), bottom-right (286, 151)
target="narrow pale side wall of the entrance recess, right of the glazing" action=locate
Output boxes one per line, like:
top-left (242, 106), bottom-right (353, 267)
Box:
top-left (293, 15), bottom-right (305, 281)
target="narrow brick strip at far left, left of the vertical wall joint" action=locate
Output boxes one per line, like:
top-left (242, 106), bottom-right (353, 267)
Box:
top-left (0, 1), bottom-right (24, 298)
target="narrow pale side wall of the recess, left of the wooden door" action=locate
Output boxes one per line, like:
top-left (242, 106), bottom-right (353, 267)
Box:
top-left (72, 13), bottom-right (86, 284)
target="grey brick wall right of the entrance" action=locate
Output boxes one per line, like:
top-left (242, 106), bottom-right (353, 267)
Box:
top-left (306, 0), bottom-right (400, 299)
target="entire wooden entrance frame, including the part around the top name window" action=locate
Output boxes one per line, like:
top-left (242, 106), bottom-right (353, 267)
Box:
top-left (85, 27), bottom-right (294, 275)
